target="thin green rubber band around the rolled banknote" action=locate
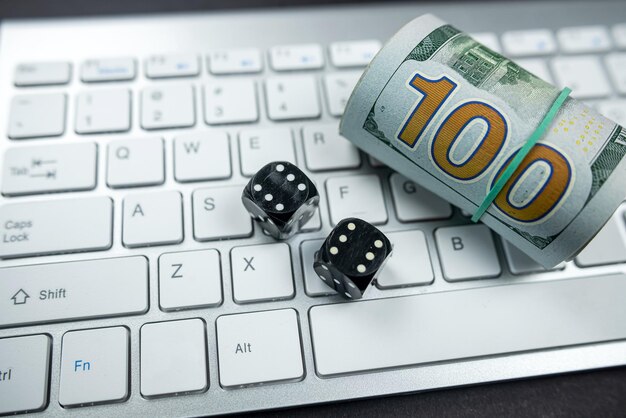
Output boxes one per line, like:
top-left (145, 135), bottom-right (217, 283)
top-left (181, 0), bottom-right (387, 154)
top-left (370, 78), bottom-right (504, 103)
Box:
top-left (472, 87), bottom-right (572, 222)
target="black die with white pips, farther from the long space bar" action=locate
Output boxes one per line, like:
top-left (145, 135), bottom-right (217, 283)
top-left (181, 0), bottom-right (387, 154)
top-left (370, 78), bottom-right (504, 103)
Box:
top-left (241, 161), bottom-right (320, 239)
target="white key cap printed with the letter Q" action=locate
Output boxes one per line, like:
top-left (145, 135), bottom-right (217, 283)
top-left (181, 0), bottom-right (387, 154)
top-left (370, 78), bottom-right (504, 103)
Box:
top-left (107, 138), bottom-right (165, 187)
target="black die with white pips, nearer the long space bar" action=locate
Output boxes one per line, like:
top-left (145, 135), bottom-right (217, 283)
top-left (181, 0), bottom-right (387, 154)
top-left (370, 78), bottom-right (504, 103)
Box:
top-left (313, 218), bottom-right (392, 299)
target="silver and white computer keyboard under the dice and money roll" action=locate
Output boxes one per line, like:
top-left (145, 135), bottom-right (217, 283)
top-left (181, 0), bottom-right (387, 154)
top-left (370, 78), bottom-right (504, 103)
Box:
top-left (0, 1), bottom-right (626, 417)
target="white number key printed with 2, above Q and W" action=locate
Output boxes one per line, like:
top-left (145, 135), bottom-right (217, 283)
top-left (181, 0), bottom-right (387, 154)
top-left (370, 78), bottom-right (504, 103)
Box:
top-left (141, 85), bottom-right (196, 129)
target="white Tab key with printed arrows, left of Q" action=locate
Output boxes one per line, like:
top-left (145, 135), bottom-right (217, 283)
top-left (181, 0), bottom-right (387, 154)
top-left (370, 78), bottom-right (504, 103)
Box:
top-left (2, 142), bottom-right (97, 196)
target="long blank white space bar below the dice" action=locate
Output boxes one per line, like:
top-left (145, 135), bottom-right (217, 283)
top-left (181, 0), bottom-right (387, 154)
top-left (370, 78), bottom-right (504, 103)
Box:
top-left (309, 274), bottom-right (626, 376)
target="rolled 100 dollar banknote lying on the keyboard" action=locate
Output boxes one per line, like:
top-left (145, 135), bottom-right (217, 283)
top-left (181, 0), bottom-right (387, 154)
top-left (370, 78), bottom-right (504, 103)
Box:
top-left (340, 15), bottom-right (626, 267)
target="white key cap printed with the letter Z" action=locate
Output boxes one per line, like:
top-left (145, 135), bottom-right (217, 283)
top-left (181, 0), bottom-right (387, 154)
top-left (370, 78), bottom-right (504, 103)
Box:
top-left (159, 250), bottom-right (222, 311)
